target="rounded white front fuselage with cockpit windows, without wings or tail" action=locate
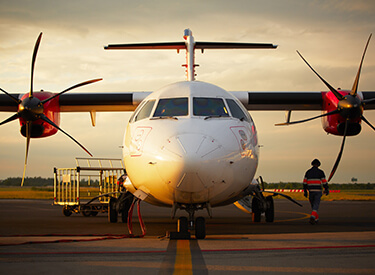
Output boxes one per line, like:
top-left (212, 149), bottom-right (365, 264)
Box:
top-left (123, 81), bottom-right (259, 209)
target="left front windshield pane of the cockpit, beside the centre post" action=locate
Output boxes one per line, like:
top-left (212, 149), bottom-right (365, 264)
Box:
top-left (154, 97), bottom-right (188, 117)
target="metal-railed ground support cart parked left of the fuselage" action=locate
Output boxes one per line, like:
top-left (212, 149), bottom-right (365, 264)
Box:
top-left (54, 158), bottom-right (126, 221)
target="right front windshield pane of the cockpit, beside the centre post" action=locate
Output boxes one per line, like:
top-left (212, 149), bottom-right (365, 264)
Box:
top-left (193, 97), bottom-right (229, 117)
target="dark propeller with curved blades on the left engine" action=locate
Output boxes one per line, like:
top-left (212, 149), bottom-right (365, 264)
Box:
top-left (0, 33), bottom-right (102, 186)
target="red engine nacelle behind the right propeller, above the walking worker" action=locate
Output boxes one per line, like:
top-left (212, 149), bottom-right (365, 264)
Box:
top-left (322, 90), bottom-right (362, 136)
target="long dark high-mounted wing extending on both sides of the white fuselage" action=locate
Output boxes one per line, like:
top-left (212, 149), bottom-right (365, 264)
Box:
top-left (0, 91), bottom-right (375, 112)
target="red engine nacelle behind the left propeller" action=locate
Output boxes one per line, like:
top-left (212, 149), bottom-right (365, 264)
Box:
top-left (19, 91), bottom-right (60, 138)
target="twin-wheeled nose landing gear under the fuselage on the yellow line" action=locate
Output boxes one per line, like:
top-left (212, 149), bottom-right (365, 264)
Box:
top-left (170, 203), bottom-right (212, 240)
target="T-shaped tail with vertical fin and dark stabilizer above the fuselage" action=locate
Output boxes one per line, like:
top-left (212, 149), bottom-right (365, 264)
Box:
top-left (104, 29), bottom-right (277, 81)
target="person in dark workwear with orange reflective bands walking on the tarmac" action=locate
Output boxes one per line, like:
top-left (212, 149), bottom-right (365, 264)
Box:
top-left (303, 159), bottom-right (329, 224)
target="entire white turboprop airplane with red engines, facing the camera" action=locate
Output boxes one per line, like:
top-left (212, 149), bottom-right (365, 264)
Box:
top-left (0, 29), bottom-right (375, 239)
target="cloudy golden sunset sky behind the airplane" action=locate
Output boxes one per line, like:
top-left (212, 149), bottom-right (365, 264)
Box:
top-left (0, 0), bottom-right (375, 183)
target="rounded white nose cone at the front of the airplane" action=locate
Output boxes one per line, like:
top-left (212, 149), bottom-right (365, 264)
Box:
top-left (157, 134), bottom-right (223, 192)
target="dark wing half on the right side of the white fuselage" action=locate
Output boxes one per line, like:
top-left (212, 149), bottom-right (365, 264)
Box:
top-left (231, 91), bottom-right (375, 111)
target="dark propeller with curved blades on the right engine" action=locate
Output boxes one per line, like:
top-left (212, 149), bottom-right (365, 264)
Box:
top-left (276, 34), bottom-right (375, 181)
